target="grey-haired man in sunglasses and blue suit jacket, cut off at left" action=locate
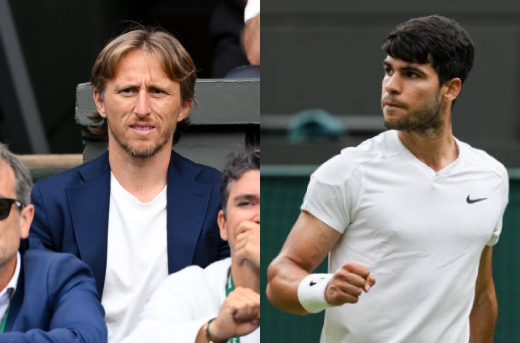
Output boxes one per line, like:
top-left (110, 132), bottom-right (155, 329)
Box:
top-left (0, 143), bottom-right (107, 343)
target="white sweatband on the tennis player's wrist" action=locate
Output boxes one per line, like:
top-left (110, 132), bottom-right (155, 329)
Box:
top-left (298, 274), bottom-right (332, 313)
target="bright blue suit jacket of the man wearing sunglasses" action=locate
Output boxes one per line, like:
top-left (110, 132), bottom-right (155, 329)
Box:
top-left (0, 240), bottom-right (108, 343)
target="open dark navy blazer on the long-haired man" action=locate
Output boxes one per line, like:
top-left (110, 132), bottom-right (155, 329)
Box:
top-left (30, 151), bottom-right (229, 296)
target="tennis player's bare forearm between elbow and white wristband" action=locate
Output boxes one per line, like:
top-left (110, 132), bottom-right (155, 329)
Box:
top-left (266, 257), bottom-right (309, 315)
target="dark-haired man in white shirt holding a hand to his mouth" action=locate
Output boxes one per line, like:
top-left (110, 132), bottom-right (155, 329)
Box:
top-left (123, 150), bottom-right (260, 343)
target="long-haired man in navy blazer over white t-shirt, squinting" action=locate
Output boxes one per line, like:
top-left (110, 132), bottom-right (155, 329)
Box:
top-left (31, 28), bottom-right (229, 343)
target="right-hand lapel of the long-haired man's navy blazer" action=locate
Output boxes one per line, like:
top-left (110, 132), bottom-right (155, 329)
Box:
top-left (166, 155), bottom-right (216, 274)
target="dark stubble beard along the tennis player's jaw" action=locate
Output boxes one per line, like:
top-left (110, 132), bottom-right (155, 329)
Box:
top-left (384, 94), bottom-right (443, 134)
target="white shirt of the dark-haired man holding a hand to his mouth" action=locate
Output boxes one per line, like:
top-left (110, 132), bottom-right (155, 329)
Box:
top-left (123, 258), bottom-right (260, 343)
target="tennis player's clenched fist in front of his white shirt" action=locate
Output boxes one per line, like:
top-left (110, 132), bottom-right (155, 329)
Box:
top-left (325, 262), bottom-right (376, 306)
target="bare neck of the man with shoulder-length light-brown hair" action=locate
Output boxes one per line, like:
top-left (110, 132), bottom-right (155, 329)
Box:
top-left (108, 146), bottom-right (171, 202)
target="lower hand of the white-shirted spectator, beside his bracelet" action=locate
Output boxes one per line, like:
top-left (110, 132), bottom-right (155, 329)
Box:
top-left (209, 287), bottom-right (260, 342)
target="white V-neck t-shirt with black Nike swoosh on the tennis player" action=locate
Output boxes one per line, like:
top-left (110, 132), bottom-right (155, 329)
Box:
top-left (301, 131), bottom-right (508, 343)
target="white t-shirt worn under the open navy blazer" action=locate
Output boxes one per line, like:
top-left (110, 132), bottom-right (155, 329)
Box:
top-left (101, 175), bottom-right (168, 343)
